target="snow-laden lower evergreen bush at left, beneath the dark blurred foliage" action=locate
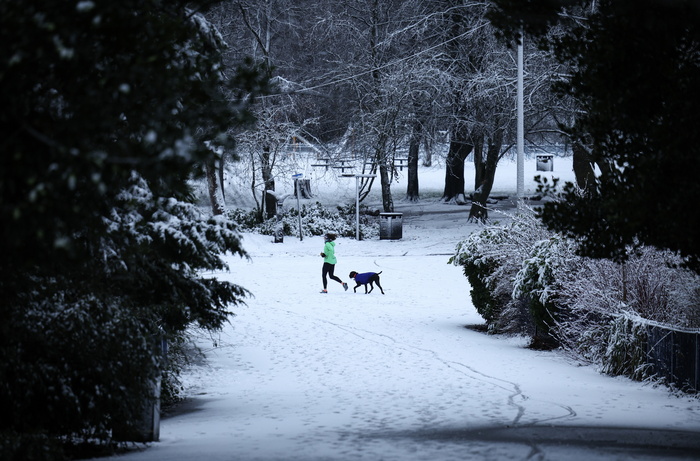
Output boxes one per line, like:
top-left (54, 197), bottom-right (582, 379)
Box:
top-left (0, 173), bottom-right (252, 452)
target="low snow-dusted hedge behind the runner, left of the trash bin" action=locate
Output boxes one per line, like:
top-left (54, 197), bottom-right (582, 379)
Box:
top-left (228, 202), bottom-right (379, 239)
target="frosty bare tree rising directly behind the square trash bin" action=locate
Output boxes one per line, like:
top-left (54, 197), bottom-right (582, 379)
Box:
top-left (310, 0), bottom-right (452, 211)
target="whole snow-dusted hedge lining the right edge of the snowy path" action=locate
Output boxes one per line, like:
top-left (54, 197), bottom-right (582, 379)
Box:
top-left (452, 208), bottom-right (700, 379)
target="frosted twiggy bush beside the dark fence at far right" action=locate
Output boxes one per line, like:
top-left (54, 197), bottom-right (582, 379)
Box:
top-left (551, 247), bottom-right (700, 366)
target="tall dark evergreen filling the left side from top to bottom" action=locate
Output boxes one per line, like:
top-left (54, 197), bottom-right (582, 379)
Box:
top-left (0, 0), bottom-right (265, 452)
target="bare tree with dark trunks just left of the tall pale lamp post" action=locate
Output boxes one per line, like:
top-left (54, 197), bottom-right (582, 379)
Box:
top-left (434, 1), bottom-right (516, 220)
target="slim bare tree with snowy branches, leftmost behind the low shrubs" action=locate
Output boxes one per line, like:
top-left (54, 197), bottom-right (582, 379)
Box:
top-left (209, 0), bottom-right (322, 218)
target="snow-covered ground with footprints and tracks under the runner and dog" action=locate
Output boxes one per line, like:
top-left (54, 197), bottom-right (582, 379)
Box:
top-left (100, 159), bottom-right (700, 461)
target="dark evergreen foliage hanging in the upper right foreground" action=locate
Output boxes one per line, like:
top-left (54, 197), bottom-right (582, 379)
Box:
top-left (491, 0), bottom-right (700, 272)
